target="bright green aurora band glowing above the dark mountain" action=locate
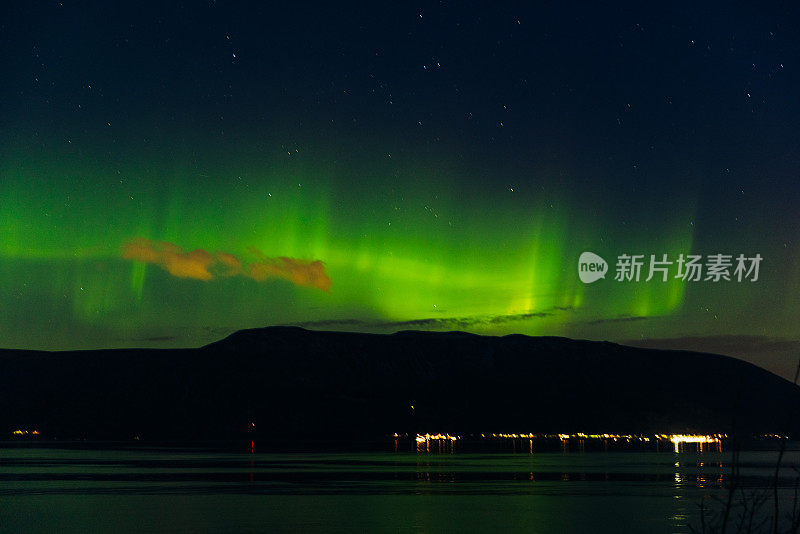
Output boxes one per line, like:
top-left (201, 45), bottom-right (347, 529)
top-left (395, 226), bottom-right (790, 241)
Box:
top-left (0, 147), bottom-right (792, 354)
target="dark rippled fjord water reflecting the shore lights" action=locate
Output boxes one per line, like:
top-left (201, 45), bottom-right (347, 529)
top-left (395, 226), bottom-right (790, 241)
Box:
top-left (0, 445), bottom-right (800, 534)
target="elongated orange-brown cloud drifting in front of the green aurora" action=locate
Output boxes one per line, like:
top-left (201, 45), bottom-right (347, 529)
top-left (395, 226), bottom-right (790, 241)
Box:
top-left (122, 237), bottom-right (331, 291)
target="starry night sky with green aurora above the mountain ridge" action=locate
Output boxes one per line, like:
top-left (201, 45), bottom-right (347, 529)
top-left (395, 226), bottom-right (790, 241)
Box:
top-left (0, 4), bottom-right (800, 382)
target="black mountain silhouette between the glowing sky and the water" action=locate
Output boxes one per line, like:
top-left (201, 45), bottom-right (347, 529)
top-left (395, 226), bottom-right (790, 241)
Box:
top-left (0, 327), bottom-right (800, 440)
